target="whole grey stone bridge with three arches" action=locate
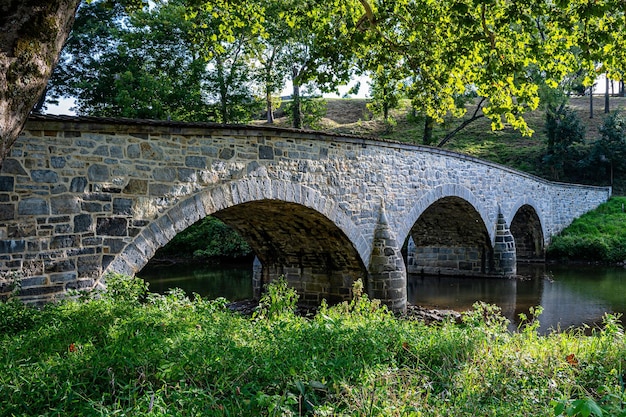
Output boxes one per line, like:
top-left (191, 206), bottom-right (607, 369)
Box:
top-left (0, 116), bottom-right (611, 310)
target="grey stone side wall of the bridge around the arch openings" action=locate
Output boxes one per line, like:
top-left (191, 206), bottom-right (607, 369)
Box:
top-left (0, 116), bottom-right (611, 308)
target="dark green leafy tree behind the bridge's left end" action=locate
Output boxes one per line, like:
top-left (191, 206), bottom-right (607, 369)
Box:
top-left (50, 1), bottom-right (217, 120)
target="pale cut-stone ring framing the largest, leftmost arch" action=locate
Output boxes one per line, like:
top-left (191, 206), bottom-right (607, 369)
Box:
top-left (105, 177), bottom-right (371, 300)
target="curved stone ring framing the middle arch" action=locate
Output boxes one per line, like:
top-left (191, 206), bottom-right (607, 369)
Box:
top-left (398, 184), bottom-right (496, 246)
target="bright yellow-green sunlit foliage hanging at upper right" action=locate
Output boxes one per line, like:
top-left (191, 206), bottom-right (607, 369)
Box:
top-left (354, 0), bottom-right (623, 143)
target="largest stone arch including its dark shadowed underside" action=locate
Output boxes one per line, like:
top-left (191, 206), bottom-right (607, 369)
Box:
top-left (104, 177), bottom-right (371, 302)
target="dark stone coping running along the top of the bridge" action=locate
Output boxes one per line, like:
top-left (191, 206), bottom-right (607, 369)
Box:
top-left (25, 113), bottom-right (612, 196)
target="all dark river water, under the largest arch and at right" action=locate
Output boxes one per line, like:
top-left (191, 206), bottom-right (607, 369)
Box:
top-left (138, 263), bottom-right (626, 332)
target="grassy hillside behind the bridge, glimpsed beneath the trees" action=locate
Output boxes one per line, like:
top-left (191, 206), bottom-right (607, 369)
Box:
top-left (264, 96), bottom-right (626, 195)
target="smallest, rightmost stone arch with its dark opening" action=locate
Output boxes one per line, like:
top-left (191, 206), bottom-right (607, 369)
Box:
top-left (508, 198), bottom-right (546, 260)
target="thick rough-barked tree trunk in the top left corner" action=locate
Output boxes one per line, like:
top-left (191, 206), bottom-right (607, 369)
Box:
top-left (0, 0), bottom-right (80, 168)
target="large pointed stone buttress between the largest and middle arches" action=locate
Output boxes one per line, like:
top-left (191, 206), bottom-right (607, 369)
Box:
top-left (366, 203), bottom-right (407, 312)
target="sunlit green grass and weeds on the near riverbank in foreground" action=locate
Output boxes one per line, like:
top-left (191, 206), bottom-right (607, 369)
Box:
top-left (0, 276), bottom-right (626, 416)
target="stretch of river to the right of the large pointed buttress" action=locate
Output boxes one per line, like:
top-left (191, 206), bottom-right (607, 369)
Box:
top-left (408, 264), bottom-right (626, 332)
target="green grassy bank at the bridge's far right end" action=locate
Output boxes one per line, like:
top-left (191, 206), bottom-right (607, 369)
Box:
top-left (547, 197), bottom-right (626, 262)
